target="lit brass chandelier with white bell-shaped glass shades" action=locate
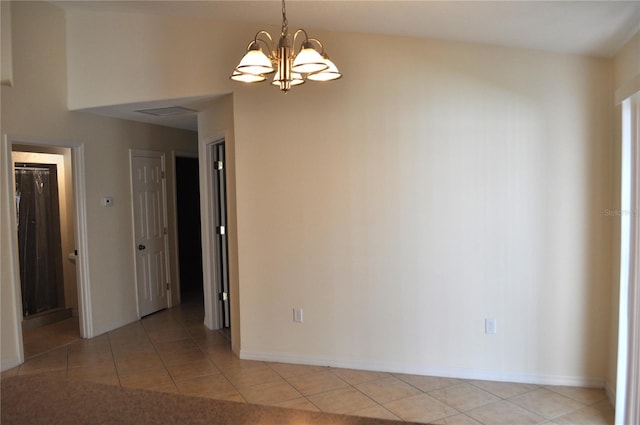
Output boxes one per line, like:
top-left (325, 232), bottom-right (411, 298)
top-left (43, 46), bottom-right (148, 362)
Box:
top-left (230, 0), bottom-right (342, 93)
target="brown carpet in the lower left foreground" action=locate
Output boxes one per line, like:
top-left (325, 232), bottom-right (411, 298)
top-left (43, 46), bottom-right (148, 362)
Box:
top-left (0, 375), bottom-right (424, 425)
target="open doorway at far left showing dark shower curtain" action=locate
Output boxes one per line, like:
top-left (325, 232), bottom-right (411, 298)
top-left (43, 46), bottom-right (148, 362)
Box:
top-left (11, 145), bottom-right (80, 357)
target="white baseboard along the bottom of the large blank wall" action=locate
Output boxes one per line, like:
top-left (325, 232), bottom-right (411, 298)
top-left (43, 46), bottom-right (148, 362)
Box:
top-left (240, 350), bottom-right (605, 388)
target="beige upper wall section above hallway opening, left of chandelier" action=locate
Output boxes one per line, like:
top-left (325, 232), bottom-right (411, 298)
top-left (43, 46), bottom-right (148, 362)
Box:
top-left (67, 10), bottom-right (255, 110)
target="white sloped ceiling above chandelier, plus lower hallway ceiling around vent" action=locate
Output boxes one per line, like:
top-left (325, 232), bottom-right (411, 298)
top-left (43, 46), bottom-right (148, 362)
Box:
top-left (52, 0), bottom-right (640, 129)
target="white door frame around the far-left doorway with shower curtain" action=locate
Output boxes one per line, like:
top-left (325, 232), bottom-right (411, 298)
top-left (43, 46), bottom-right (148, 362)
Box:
top-left (0, 134), bottom-right (94, 363)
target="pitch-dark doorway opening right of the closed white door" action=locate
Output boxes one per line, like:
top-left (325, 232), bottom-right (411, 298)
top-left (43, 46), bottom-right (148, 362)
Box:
top-left (175, 157), bottom-right (204, 303)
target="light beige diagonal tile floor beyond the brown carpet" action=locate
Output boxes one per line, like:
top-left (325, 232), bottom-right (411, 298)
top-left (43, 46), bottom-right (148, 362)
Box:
top-left (2, 303), bottom-right (614, 425)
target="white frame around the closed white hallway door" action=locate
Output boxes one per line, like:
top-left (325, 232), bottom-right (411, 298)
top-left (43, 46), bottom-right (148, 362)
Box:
top-left (129, 149), bottom-right (173, 318)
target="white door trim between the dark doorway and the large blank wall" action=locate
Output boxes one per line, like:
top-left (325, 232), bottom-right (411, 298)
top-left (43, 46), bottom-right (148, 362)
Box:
top-left (198, 132), bottom-right (225, 329)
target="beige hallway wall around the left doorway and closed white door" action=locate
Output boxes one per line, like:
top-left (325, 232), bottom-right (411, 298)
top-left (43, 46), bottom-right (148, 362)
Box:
top-left (0, 2), bottom-right (197, 370)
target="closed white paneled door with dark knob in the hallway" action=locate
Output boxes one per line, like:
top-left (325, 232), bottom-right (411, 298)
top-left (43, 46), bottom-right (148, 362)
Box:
top-left (131, 151), bottom-right (169, 316)
